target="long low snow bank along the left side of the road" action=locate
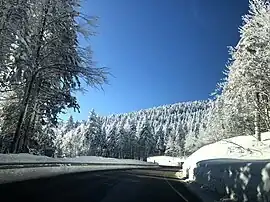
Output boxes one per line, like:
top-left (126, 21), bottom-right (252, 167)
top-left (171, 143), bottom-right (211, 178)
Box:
top-left (0, 153), bottom-right (151, 165)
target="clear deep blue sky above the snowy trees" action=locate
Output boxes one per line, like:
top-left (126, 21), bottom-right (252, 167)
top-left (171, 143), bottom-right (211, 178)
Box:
top-left (64, 0), bottom-right (248, 120)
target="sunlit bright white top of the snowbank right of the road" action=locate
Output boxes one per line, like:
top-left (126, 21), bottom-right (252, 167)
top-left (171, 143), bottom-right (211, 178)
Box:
top-left (183, 132), bottom-right (270, 179)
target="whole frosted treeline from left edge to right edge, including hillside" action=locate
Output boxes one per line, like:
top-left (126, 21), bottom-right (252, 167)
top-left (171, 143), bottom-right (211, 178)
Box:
top-left (0, 0), bottom-right (270, 159)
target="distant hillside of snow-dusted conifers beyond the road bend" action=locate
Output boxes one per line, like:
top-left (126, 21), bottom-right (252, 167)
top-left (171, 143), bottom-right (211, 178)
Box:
top-left (55, 101), bottom-right (212, 159)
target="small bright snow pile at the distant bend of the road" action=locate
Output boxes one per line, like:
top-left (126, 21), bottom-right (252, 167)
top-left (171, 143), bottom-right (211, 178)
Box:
top-left (147, 156), bottom-right (185, 166)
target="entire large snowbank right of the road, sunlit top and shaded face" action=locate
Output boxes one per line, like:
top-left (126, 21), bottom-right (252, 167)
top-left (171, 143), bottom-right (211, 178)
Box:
top-left (183, 132), bottom-right (270, 201)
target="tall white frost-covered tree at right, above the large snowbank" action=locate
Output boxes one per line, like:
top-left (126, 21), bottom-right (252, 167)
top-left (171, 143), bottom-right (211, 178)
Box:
top-left (218, 0), bottom-right (270, 140)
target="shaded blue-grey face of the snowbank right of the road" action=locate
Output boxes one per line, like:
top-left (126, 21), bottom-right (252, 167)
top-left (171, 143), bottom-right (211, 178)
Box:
top-left (194, 159), bottom-right (270, 201)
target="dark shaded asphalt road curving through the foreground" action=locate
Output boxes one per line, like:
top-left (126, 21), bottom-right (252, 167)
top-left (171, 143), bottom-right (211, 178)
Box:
top-left (0, 168), bottom-right (201, 202)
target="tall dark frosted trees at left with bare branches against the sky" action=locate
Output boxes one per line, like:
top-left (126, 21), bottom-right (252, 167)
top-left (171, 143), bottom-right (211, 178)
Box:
top-left (0, 0), bottom-right (106, 152)
